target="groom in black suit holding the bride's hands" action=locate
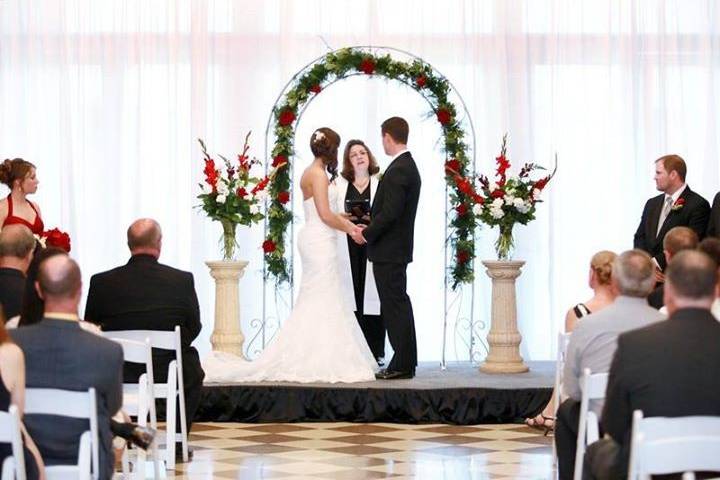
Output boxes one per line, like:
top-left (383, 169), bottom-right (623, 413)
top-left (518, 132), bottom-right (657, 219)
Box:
top-left (361, 117), bottom-right (420, 380)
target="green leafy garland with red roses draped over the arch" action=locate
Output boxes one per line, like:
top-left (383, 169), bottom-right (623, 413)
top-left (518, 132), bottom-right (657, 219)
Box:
top-left (263, 48), bottom-right (476, 289)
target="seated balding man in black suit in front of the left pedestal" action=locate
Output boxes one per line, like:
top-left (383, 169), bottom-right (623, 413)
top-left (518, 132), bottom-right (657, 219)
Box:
top-left (85, 219), bottom-right (205, 452)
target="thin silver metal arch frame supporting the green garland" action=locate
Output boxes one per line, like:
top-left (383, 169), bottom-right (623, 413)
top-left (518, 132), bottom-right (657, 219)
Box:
top-left (247, 45), bottom-right (487, 370)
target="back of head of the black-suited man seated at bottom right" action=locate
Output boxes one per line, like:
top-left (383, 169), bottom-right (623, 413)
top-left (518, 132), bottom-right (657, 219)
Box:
top-left (666, 250), bottom-right (718, 300)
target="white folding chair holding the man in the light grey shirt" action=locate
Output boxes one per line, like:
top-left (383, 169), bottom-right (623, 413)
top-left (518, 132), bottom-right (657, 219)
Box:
top-left (573, 368), bottom-right (608, 480)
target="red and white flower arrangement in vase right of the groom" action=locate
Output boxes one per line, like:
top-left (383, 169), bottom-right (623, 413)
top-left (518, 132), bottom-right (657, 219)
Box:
top-left (455, 134), bottom-right (557, 260)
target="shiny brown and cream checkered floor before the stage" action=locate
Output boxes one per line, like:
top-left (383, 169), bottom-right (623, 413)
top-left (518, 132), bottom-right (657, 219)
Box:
top-left (168, 423), bottom-right (553, 480)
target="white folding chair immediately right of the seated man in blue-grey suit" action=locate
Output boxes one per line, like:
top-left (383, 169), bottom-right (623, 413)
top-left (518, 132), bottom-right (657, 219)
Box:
top-left (103, 338), bottom-right (160, 479)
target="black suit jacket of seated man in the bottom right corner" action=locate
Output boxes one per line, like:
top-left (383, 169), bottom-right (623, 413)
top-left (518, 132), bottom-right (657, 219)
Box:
top-left (602, 308), bottom-right (720, 471)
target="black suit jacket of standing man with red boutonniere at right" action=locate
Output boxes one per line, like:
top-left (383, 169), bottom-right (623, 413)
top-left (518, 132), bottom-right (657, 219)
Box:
top-left (634, 186), bottom-right (710, 270)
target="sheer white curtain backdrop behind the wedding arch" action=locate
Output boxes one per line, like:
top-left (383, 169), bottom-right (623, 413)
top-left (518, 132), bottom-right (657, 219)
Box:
top-left (0, 0), bottom-right (720, 360)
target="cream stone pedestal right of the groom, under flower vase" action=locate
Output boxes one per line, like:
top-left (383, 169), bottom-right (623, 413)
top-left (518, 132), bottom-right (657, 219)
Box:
top-left (480, 260), bottom-right (529, 373)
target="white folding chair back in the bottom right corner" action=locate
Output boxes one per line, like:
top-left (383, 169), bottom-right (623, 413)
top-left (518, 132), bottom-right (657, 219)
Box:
top-left (628, 410), bottom-right (720, 480)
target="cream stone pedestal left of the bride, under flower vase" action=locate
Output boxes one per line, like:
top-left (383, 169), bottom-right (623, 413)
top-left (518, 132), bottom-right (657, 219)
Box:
top-left (205, 260), bottom-right (248, 357)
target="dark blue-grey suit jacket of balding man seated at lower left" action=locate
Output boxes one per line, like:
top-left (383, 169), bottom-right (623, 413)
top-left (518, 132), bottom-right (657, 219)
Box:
top-left (10, 318), bottom-right (123, 479)
